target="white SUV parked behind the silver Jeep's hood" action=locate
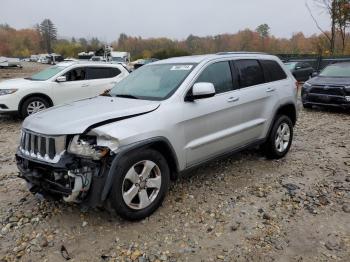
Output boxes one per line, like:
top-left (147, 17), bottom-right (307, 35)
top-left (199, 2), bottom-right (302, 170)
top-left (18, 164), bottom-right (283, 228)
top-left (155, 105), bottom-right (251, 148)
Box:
top-left (0, 62), bottom-right (129, 118)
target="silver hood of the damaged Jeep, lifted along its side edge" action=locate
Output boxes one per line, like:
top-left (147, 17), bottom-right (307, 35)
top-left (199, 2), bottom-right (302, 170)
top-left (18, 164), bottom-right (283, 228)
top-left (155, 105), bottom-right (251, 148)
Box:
top-left (22, 96), bottom-right (160, 135)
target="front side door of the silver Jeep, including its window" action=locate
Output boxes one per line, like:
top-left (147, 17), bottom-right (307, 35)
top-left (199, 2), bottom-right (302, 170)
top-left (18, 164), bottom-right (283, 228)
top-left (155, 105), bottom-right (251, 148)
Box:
top-left (183, 61), bottom-right (241, 166)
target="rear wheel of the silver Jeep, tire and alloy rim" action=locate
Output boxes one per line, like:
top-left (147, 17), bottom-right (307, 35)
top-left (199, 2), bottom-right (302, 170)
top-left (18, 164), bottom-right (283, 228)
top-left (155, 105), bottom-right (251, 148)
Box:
top-left (262, 115), bottom-right (293, 159)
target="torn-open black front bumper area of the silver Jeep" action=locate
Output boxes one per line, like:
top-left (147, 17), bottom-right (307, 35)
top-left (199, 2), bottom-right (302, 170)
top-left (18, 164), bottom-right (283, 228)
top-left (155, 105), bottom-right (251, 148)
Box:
top-left (16, 150), bottom-right (108, 207)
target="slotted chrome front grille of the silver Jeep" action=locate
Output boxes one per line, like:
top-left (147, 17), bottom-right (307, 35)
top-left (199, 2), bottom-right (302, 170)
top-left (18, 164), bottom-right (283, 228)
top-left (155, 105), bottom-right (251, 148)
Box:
top-left (19, 130), bottom-right (66, 163)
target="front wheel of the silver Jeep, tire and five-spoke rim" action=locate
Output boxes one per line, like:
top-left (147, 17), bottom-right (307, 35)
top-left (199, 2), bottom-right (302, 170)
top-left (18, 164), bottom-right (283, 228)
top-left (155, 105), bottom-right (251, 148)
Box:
top-left (109, 149), bottom-right (170, 221)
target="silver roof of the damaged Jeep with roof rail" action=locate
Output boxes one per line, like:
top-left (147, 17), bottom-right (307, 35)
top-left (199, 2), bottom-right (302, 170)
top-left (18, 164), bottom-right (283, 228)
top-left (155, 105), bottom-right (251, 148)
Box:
top-left (156, 52), bottom-right (275, 64)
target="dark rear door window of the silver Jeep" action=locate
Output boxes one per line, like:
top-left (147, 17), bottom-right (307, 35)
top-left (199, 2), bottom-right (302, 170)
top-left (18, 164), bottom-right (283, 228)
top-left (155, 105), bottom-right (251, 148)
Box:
top-left (234, 59), bottom-right (265, 87)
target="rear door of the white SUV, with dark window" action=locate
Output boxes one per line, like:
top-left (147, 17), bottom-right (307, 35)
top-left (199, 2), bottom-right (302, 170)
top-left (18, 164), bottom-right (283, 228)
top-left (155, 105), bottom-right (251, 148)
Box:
top-left (86, 66), bottom-right (122, 96)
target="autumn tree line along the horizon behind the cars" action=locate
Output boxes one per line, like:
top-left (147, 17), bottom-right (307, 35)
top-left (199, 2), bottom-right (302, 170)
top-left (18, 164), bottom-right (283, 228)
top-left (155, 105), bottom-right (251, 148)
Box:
top-left (0, 0), bottom-right (350, 59)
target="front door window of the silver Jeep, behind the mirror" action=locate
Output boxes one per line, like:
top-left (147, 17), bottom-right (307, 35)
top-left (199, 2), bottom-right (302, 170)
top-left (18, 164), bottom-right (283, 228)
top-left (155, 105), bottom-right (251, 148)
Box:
top-left (196, 61), bottom-right (233, 94)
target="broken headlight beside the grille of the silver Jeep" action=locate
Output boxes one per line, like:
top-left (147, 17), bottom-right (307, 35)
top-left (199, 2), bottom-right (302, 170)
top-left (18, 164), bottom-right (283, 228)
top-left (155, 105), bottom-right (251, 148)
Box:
top-left (68, 135), bottom-right (109, 160)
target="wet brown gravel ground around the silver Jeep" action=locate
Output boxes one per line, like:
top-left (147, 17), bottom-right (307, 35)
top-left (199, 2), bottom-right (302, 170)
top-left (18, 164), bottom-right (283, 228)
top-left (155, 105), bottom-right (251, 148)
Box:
top-left (0, 65), bottom-right (350, 261)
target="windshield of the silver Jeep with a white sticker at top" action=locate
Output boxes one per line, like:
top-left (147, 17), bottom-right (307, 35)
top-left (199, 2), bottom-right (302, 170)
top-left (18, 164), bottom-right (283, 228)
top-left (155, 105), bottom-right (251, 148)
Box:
top-left (110, 64), bottom-right (195, 100)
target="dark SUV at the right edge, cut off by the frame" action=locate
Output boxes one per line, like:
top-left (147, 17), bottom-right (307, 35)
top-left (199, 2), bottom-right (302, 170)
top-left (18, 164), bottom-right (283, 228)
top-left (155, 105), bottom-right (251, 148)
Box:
top-left (301, 62), bottom-right (350, 108)
